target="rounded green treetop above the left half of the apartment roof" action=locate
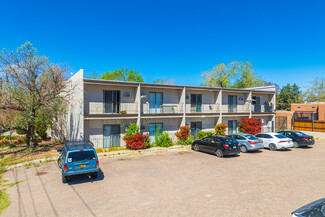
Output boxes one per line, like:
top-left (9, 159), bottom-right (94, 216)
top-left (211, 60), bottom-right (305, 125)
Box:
top-left (100, 68), bottom-right (143, 82)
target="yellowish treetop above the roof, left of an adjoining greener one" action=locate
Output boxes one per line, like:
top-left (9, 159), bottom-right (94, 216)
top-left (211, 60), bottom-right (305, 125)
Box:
top-left (201, 61), bottom-right (239, 87)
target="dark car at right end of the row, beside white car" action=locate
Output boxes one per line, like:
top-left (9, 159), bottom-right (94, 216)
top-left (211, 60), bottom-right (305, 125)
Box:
top-left (278, 130), bottom-right (315, 148)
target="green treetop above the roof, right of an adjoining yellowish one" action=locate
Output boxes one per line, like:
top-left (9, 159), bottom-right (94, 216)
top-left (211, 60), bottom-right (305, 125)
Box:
top-left (233, 61), bottom-right (266, 88)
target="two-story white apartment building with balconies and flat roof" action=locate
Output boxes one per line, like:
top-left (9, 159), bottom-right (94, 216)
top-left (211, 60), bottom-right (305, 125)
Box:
top-left (56, 70), bottom-right (275, 147)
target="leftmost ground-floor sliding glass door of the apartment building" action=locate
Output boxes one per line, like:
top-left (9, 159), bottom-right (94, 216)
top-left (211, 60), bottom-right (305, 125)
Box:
top-left (104, 125), bottom-right (120, 148)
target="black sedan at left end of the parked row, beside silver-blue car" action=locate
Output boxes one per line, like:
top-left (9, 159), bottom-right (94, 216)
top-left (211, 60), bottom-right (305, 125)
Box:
top-left (192, 136), bottom-right (240, 157)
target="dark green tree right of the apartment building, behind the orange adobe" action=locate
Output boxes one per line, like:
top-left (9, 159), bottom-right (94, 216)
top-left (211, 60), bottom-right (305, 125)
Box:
top-left (276, 84), bottom-right (303, 111)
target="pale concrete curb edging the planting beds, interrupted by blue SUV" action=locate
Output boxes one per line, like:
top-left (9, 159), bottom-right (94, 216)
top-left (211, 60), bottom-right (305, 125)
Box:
top-left (6, 145), bottom-right (191, 171)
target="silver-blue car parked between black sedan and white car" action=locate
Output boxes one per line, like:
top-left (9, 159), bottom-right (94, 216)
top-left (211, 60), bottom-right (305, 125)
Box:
top-left (230, 133), bottom-right (264, 153)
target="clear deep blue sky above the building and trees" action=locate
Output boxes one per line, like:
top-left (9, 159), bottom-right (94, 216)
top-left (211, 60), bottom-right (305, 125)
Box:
top-left (0, 0), bottom-right (325, 87)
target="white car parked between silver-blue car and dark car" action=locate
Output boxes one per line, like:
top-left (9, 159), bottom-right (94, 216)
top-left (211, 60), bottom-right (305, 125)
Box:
top-left (256, 133), bottom-right (293, 151)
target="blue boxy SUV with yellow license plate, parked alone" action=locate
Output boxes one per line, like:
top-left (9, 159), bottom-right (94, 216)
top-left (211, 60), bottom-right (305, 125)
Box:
top-left (58, 142), bottom-right (99, 183)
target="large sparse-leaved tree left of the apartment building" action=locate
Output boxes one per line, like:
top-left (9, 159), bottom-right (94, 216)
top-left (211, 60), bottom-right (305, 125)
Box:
top-left (0, 42), bottom-right (68, 147)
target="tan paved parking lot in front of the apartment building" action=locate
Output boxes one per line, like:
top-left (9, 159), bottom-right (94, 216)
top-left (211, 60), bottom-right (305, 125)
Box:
top-left (3, 140), bottom-right (325, 217)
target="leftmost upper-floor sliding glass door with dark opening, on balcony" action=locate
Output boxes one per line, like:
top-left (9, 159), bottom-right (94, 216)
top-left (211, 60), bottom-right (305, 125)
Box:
top-left (104, 90), bottom-right (120, 113)
